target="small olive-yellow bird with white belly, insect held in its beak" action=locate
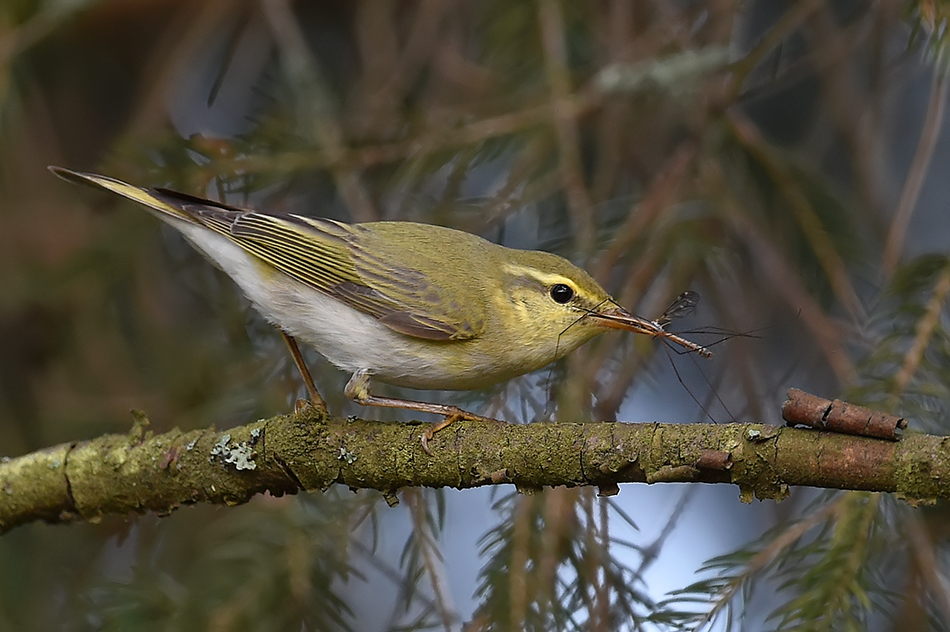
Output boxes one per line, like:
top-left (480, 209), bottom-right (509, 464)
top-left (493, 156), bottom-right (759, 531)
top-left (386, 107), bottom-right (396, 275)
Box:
top-left (50, 167), bottom-right (712, 452)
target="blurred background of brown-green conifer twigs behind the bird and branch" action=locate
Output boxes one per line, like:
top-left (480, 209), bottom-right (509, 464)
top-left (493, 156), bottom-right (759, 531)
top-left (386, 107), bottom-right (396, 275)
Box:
top-left (0, 0), bottom-right (950, 631)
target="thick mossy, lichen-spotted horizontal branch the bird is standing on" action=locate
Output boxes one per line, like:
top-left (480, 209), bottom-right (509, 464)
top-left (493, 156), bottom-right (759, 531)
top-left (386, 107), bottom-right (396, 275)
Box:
top-left (0, 406), bottom-right (950, 533)
